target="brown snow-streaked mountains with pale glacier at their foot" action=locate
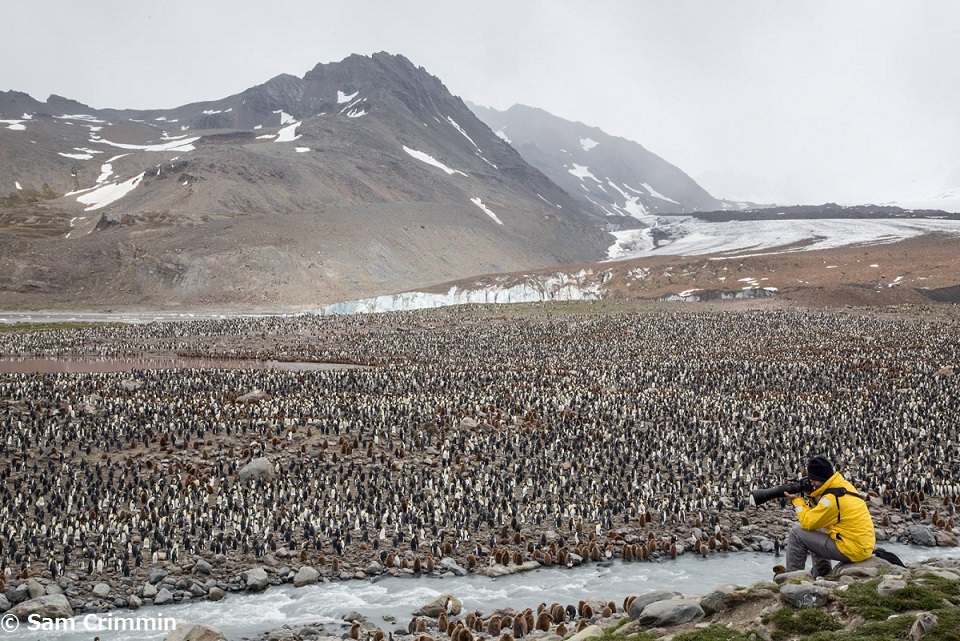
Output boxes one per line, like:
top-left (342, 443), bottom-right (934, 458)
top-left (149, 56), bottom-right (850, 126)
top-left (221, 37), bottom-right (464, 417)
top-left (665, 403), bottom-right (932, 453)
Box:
top-left (0, 53), bottom-right (958, 310)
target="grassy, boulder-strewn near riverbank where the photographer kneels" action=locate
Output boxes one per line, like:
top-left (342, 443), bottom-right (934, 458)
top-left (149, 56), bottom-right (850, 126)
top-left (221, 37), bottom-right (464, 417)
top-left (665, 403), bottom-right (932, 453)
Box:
top-left (125, 557), bottom-right (960, 641)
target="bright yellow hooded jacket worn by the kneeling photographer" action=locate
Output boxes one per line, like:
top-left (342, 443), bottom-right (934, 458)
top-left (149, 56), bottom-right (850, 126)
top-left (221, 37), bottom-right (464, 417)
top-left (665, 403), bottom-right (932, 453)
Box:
top-left (793, 472), bottom-right (877, 563)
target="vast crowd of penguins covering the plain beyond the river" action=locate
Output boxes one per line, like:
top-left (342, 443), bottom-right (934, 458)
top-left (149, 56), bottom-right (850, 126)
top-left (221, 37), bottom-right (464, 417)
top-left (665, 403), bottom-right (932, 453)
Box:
top-left (0, 308), bottom-right (960, 604)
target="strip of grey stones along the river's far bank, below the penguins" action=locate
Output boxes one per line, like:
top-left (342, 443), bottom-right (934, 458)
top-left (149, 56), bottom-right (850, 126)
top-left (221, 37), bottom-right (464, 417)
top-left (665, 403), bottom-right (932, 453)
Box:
top-left (0, 500), bottom-right (960, 617)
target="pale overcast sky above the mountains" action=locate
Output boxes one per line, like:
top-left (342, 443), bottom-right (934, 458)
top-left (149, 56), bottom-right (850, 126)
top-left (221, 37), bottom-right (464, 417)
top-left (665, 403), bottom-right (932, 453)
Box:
top-left (0, 0), bottom-right (960, 204)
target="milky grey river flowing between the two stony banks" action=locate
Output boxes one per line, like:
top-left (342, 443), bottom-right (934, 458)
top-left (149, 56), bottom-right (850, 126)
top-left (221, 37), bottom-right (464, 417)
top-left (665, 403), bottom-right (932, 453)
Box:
top-left (0, 543), bottom-right (960, 641)
